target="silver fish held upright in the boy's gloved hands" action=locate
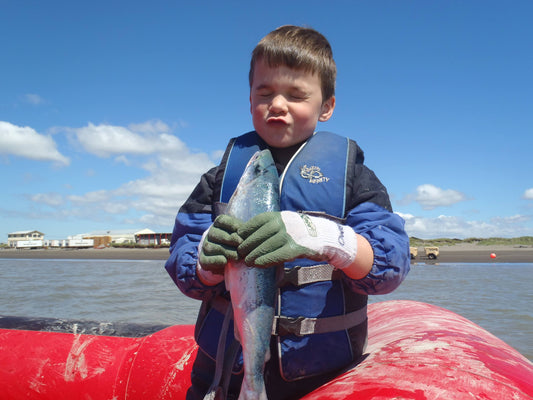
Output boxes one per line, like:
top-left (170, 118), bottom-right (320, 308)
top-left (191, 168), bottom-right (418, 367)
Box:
top-left (225, 150), bottom-right (280, 400)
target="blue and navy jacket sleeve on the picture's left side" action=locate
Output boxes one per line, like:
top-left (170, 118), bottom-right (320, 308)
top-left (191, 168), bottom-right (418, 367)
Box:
top-left (165, 167), bottom-right (224, 300)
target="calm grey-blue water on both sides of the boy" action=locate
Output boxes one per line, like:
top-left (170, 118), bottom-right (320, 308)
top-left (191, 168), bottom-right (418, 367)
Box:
top-left (0, 259), bottom-right (533, 360)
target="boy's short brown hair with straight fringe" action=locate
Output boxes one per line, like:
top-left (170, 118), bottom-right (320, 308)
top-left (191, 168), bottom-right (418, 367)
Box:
top-left (248, 25), bottom-right (337, 101)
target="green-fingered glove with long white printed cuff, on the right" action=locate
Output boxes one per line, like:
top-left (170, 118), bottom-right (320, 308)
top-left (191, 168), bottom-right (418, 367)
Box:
top-left (237, 211), bottom-right (357, 269)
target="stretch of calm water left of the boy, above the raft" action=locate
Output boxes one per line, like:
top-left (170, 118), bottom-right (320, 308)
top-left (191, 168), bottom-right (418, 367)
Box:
top-left (0, 259), bottom-right (200, 325)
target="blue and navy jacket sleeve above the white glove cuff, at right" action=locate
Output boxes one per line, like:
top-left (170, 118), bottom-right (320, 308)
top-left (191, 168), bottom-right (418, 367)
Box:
top-left (346, 164), bottom-right (411, 295)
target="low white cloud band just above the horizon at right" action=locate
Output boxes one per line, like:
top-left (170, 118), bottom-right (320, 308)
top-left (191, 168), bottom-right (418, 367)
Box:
top-left (398, 213), bottom-right (532, 239)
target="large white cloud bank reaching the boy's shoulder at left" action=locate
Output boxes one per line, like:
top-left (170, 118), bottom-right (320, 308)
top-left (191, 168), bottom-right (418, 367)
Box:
top-left (26, 120), bottom-right (219, 234)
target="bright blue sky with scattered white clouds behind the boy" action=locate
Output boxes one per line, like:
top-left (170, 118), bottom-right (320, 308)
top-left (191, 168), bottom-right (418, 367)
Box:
top-left (0, 0), bottom-right (533, 242)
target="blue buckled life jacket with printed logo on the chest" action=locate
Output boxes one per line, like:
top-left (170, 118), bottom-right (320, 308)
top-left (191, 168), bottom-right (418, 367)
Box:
top-left (197, 132), bottom-right (367, 381)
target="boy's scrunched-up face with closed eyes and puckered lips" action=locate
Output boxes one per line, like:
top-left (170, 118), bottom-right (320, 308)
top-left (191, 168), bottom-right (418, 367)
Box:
top-left (250, 60), bottom-right (335, 147)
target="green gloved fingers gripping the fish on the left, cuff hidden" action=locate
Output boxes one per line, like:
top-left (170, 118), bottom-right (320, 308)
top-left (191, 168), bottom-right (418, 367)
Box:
top-left (198, 215), bottom-right (242, 275)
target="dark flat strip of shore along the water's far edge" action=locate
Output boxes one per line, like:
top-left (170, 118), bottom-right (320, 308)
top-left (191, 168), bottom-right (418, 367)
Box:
top-left (0, 244), bottom-right (533, 264)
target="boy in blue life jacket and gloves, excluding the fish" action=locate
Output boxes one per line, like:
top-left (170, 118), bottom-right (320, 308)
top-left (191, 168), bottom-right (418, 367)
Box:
top-left (166, 26), bottom-right (409, 399)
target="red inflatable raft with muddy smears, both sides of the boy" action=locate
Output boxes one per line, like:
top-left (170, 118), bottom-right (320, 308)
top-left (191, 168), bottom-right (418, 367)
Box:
top-left (0, 301), bottom-right (533, 400)
